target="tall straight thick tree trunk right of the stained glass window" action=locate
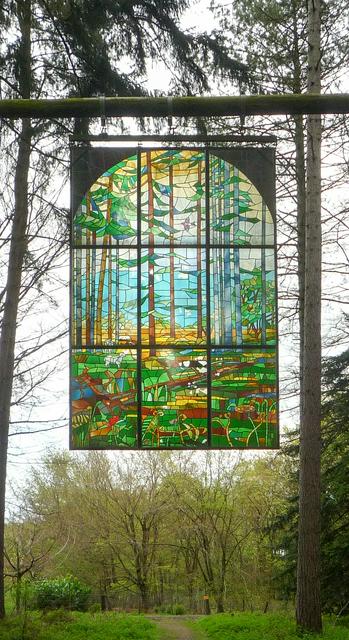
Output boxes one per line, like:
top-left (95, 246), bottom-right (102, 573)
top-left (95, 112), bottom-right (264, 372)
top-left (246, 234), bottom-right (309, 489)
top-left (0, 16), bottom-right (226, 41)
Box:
top-left (296, 0), bottom-right (322, 632)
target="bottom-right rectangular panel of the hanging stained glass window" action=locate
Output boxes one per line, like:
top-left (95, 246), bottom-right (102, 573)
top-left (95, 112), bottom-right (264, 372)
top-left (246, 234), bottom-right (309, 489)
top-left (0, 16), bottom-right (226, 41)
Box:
top-left (211, 349), bottom-right (278, 448)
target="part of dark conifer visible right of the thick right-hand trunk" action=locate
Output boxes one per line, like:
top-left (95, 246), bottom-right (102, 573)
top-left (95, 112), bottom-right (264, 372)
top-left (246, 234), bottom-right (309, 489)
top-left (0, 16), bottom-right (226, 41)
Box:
top-left (321, 340), bottom-right (349, 615)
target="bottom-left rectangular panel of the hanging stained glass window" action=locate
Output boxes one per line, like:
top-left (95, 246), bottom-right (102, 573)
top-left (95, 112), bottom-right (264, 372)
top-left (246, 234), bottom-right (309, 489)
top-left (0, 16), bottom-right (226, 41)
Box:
top-left (71, 349), bottom-right (137, 449)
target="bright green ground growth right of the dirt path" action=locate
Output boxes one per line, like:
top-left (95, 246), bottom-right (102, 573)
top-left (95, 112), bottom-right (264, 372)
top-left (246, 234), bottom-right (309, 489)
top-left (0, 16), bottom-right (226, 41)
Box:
top-left (193, 613), bottom-right (349, 640)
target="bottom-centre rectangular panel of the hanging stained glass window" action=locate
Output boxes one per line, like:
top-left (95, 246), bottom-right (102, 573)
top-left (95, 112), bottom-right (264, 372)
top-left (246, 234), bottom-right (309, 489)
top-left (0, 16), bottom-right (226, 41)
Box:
top-left (142, 349), bottom-right (207, 449)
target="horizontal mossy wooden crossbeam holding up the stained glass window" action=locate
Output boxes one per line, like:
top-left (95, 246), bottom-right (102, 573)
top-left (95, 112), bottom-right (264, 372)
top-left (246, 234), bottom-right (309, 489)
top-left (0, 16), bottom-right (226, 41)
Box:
top-left (0, 93), bottom-right (349, 119)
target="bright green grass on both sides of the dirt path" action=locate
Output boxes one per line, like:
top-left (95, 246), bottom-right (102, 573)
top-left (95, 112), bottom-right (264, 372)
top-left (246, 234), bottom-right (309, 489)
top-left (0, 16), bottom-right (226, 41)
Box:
top-left (0, 610), bottom-right (349, 640)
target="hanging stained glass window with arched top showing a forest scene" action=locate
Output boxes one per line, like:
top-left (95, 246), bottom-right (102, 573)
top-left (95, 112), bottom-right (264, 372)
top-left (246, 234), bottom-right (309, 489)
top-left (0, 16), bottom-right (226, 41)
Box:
top-left (71, 148), bottom-right (278, 449)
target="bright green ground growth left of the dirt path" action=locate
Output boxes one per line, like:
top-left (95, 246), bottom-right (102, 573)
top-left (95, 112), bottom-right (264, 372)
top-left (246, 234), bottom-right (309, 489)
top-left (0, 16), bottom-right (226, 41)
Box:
top-left (0, 610), bottom-right (159, 640)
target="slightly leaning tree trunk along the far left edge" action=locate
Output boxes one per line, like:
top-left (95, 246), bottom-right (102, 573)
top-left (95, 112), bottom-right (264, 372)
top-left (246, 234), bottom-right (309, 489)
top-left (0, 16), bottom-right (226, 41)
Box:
top-left (0, 0), bottom-right (31, 618)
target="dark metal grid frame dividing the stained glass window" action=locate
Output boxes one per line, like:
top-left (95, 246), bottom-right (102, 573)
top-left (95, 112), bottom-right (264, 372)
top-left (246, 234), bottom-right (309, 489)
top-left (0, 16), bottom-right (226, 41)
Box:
top-left (70, 144), bottom-right (279, 451)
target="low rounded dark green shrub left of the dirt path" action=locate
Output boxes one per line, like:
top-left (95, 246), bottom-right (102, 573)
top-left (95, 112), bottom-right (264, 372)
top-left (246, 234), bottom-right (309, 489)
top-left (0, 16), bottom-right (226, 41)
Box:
top-left (34, 576), bottom-right (91, 611)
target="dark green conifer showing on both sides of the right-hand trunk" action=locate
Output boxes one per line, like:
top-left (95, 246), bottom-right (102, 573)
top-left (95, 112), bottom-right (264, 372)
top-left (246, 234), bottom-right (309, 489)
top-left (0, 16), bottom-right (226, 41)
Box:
top-left (260, 336), bottom-right (349, 616)
